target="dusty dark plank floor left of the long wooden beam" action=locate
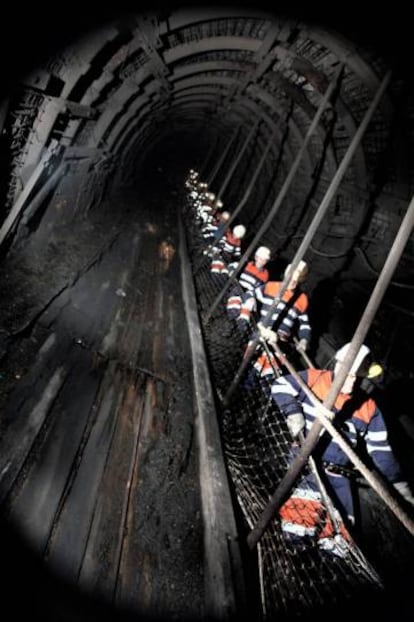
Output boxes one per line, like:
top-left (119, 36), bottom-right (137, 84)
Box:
top-left (0, 183), bottom-right (204, 620)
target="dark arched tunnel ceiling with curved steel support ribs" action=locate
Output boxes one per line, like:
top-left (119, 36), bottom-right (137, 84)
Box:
top-left (0, 4), bottom-right (412, 196)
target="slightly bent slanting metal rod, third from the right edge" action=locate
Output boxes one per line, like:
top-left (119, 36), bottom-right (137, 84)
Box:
top-left (204, 64), bottom-right (343, 324)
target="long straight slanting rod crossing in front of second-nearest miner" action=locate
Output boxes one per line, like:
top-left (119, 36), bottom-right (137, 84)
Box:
top-left (223, 72), bottom-right (391, 404)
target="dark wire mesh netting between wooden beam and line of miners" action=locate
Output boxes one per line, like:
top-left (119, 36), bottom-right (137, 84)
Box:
top-left (183, 179), bottom-right (382, 619)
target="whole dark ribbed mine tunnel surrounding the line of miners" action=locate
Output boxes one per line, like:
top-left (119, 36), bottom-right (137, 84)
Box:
top-left (0, 3), bottom-right (414, 621)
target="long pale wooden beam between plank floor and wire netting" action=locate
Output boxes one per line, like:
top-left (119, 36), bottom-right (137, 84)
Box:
top-left (180, 216), bottom-right (246, 620)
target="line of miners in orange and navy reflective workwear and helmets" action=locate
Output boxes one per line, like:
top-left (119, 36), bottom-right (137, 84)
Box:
top-left (185, 169), bottom-right (414, 555)
